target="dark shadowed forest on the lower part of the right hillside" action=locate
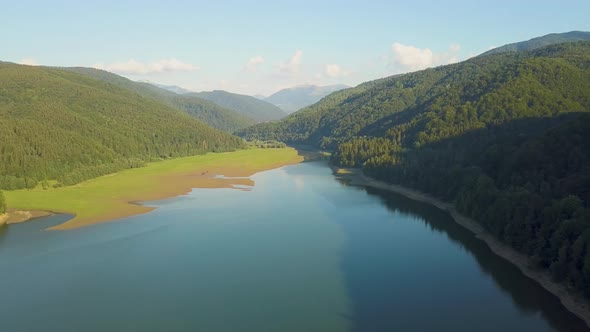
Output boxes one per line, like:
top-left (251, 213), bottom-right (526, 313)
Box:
top-left (350, 114), bottom-right (590, 296)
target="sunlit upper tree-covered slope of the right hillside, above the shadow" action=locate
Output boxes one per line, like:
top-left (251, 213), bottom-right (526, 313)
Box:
top-left (238, 42), bottom-right (590, 150)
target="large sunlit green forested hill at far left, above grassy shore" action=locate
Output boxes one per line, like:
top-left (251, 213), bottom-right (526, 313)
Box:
top-left (0, 63), bottom-right (243, 189)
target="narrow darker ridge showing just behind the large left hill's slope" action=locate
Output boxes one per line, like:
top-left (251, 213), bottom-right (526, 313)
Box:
top-left (62, 67), bottom-right (256, 133)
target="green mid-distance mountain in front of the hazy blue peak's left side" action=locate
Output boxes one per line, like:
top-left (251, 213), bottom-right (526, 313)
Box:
top-left (190, 90), bottom-right (287, 122)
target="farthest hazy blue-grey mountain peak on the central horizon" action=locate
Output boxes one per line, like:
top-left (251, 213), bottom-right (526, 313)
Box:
top-left (264, 84), bottom-right (349, 114)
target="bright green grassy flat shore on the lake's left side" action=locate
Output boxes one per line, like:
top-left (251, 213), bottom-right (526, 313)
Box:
top-left (4, 148), bottom-right (303, 230)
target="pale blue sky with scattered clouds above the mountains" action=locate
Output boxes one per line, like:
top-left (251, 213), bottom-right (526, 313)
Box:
top-left (0, 0), bottom-right (590, 95)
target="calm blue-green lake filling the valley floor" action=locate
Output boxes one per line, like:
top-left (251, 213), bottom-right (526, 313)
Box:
top-left (0, 162), bottom-right (587, 332)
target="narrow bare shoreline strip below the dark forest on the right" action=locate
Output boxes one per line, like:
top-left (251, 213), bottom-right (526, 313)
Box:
top-left (332, 167), bottom-right (590, 327)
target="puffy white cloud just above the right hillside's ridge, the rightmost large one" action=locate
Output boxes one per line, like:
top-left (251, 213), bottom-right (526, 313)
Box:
top-left (391, 43), bottom-right (461, 72)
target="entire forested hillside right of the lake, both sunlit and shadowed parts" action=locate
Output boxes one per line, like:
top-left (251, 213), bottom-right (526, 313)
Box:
top-left (240, 42), bottom-right (590, 296)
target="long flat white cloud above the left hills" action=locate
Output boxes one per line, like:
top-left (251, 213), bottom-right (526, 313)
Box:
top-left (93, 58), bottom-right (199, 75)
